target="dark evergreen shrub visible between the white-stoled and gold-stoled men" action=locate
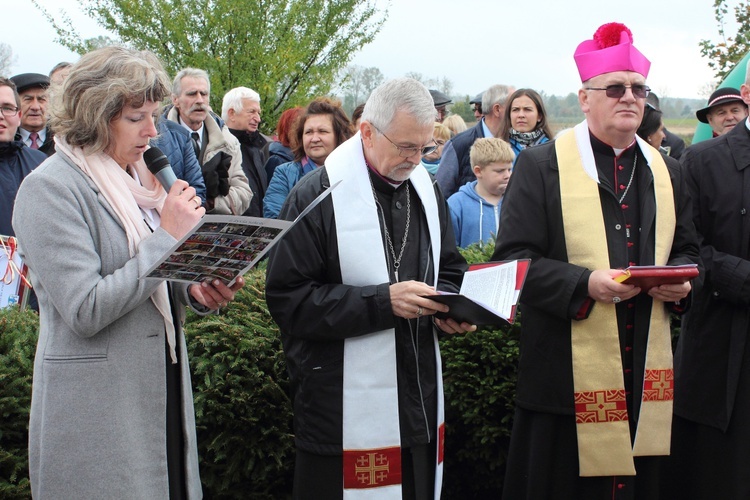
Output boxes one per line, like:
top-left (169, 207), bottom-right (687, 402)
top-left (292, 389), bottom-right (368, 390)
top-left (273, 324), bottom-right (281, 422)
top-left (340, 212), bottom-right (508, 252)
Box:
top-left (440, 239), bottom-right (521, 498)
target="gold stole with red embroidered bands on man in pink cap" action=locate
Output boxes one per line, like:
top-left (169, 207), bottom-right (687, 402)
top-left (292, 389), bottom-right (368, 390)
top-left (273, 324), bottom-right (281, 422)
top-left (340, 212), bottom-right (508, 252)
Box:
top-left (555, 122), bottom-right (676, 476)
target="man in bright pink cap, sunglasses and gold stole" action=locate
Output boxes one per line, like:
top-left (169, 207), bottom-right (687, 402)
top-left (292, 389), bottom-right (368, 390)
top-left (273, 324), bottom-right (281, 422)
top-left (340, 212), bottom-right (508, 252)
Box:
top-left (493, 23), bottom-right (698, 499)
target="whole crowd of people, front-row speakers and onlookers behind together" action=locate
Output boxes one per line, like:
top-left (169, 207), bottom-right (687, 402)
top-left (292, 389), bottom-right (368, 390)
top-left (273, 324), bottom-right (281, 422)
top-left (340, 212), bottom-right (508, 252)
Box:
top-left (0, 16), bottom-right (750, 500)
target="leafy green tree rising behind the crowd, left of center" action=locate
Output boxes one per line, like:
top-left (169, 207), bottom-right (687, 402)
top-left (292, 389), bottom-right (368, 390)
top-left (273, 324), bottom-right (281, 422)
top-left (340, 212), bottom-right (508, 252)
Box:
top-left (32, 0), bottom-right (388, 131)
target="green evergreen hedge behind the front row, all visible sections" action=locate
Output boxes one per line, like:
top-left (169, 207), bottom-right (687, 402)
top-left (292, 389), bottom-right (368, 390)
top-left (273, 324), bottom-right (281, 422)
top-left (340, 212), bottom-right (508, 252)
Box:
top-left (0, 241), bottom-right (518, 500)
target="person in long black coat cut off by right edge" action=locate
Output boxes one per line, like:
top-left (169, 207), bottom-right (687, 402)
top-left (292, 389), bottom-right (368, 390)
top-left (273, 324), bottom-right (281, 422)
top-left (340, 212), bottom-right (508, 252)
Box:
top-left (668, 63), bottom-right (750, 499)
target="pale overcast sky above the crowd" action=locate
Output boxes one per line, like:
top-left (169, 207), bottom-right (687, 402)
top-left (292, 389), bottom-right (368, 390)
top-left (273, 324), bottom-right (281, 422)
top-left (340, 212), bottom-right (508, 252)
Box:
top-left (5, 0), bottom-right (733, 98)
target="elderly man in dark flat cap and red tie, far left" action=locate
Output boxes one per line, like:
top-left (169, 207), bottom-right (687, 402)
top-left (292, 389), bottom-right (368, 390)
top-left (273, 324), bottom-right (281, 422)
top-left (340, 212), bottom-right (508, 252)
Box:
top-left (10, 73), bottom-right (55, 156)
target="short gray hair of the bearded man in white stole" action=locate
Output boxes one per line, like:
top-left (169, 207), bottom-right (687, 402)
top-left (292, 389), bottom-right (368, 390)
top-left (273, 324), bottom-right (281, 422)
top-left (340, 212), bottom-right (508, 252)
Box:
top-left (362, 78), bottom-right (436, 132)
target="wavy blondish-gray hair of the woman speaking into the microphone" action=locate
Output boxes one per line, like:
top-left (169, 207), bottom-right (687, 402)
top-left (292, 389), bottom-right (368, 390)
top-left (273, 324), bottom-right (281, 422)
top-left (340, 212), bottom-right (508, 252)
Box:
top-left (50, 47), bottom-right (170, 154)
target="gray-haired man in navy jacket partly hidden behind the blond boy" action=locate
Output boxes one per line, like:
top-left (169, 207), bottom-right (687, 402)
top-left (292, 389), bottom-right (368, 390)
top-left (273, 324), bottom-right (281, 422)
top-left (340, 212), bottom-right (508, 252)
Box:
top-left (435, 85), bottom-right (514, 198)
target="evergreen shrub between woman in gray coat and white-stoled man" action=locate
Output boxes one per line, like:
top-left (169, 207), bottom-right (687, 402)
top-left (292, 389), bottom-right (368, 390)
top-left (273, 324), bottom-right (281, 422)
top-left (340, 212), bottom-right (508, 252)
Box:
top-left (185, 266), bottom-right (294, 500)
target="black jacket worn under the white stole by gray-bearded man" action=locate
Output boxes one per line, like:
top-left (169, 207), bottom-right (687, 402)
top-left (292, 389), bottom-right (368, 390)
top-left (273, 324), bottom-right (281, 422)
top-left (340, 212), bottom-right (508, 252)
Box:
top-left (266, 166), bottom-right (466, 455)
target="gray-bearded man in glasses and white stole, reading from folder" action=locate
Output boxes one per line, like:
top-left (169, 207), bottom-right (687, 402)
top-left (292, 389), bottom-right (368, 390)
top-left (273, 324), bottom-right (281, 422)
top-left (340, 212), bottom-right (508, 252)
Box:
top-left (266, 78), bottom-right (474, 500)
